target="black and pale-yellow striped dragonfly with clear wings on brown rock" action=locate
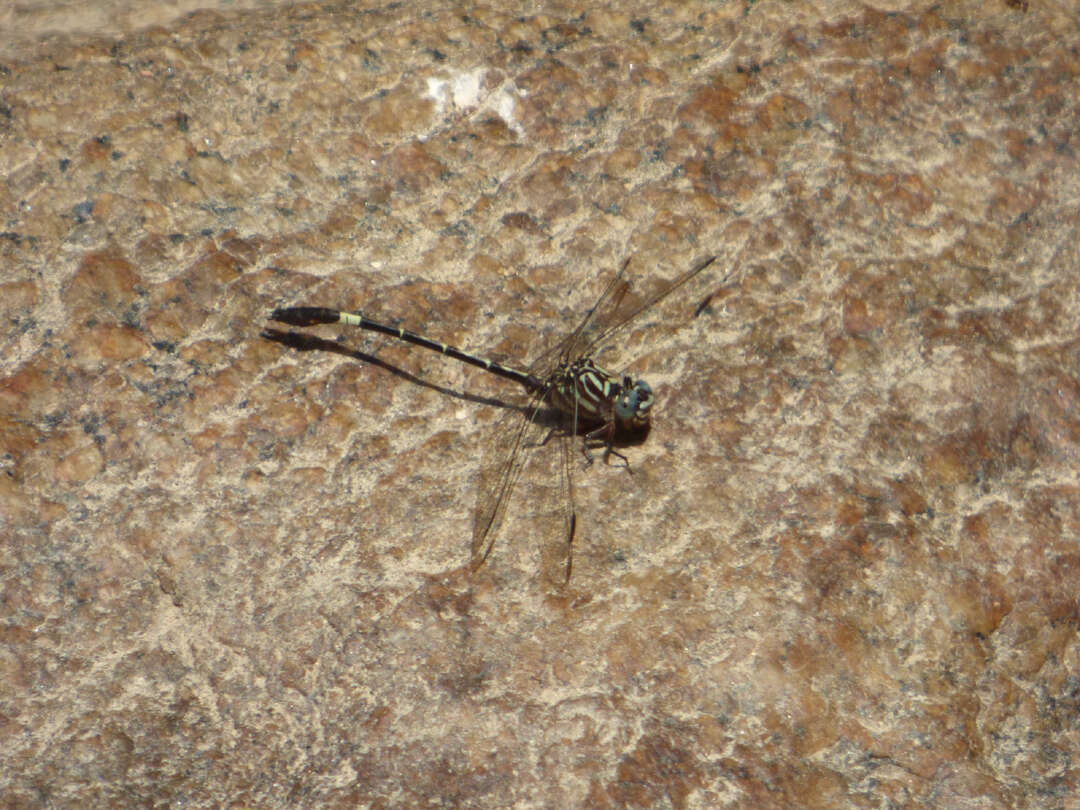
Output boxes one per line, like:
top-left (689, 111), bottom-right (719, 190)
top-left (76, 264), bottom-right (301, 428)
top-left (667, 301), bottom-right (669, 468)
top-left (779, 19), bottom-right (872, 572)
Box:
top-left (268, 256), bottom-right (733, 584)
